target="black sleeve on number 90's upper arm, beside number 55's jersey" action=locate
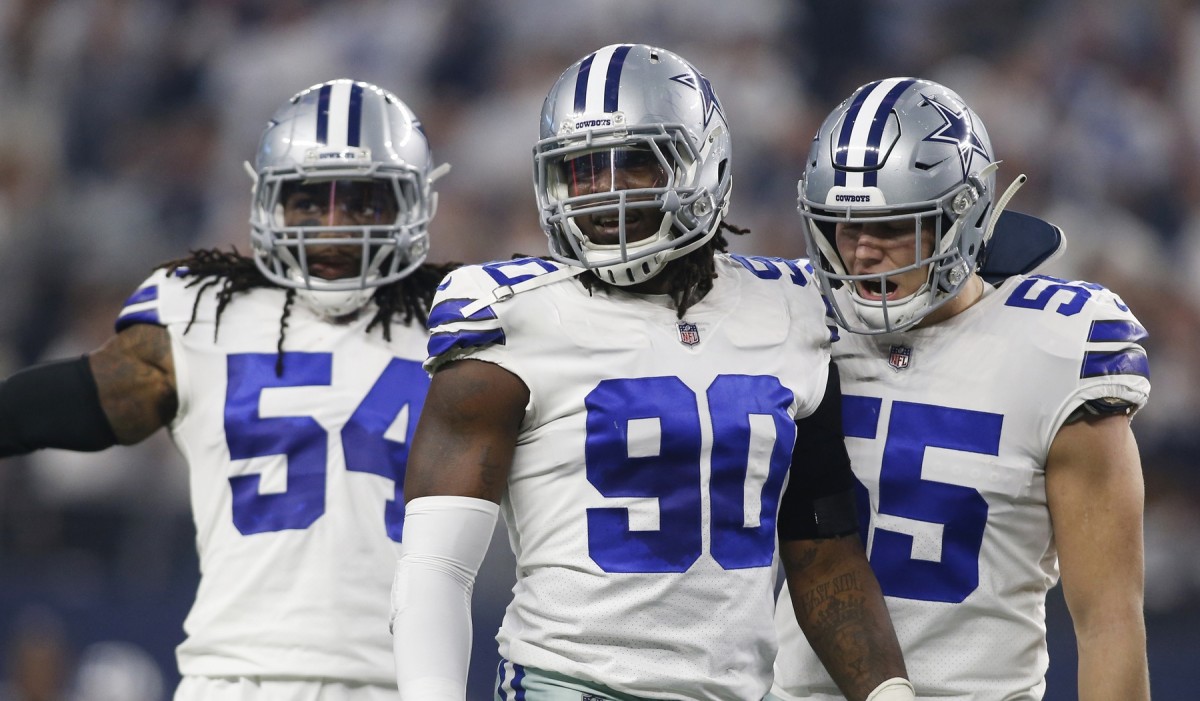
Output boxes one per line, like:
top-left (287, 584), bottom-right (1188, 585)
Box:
top-left (778, 363), bottom-right (858, 540)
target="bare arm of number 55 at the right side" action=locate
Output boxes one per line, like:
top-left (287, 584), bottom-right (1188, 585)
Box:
top-left (1046, 414), bottom-right (1150, 701)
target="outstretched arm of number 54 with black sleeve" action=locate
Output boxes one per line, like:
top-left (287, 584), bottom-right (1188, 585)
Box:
top-left (0, 324), bottom-right (179, 457)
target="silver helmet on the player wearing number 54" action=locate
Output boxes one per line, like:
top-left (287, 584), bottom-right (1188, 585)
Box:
top-left (246, 79), bottom-right (445, 318)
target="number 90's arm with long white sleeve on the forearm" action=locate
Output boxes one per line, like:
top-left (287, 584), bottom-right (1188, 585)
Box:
top-left (392, 360), bottom-right (529, 701)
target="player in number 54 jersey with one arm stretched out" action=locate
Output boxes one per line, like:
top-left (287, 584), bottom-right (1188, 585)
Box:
top-left (0, 80), bottom-right (449, 701)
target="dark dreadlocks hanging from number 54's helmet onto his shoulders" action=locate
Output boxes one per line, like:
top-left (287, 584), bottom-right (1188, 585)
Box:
top-left (158, 246), bottom-right (461, 377)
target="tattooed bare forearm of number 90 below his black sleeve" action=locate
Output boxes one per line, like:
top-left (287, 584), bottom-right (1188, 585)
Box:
top-left (780, 534), bottom-right (913, 701)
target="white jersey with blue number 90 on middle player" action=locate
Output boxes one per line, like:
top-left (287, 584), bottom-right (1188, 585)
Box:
top-left (427, 254), bottom-right (830, 700)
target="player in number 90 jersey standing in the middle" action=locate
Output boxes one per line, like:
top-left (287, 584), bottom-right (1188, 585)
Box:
top-left (394, 44), bottom-right (912, 701)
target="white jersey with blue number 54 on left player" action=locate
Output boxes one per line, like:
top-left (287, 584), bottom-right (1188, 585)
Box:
top-left (118, 270), bottom-right (428, 685)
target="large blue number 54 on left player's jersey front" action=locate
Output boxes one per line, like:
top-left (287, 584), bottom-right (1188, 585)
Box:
top-left (224, 353), bottom-right (430, 543)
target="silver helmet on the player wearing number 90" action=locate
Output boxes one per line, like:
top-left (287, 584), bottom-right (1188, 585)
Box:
top-left (534, 44), bottom-right (732, 286)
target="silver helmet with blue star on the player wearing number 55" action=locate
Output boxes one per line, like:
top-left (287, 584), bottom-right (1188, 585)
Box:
top-left (798, 78), bottom-right (1007, 334)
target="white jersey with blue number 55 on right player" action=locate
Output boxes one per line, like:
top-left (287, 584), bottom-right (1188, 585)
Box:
top-left (775, 275), bottom-right (1150, 701)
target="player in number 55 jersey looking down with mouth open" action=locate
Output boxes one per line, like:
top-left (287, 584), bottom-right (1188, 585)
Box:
top-left (775, 78), bottom-right (1150, 701)
